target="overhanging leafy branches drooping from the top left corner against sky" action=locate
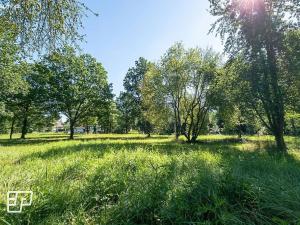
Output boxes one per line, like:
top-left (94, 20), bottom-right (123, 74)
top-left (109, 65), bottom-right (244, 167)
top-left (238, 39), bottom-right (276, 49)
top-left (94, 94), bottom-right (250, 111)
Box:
top-left (0, 0), bottom-right (91, 53)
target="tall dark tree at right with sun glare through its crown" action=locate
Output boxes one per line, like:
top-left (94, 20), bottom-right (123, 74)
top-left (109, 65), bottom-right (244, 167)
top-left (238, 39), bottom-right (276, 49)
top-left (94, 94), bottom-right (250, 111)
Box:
top-left (210, 0), bottom-right (300, 152)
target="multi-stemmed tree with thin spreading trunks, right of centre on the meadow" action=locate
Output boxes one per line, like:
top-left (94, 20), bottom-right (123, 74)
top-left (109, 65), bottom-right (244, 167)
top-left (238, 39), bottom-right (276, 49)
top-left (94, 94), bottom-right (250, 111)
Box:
top-left (160, 43), bottom-right (219, 142)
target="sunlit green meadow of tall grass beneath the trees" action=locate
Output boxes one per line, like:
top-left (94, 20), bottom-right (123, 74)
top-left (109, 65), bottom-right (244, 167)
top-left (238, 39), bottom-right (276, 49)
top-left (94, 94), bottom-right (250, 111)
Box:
top-left (0, 134), bottom-right (300, 225)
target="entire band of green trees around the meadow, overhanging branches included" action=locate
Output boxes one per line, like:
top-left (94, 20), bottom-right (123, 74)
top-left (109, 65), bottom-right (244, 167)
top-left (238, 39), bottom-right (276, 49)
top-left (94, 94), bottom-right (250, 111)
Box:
top-left (0, 0), bottom-right (300, 152)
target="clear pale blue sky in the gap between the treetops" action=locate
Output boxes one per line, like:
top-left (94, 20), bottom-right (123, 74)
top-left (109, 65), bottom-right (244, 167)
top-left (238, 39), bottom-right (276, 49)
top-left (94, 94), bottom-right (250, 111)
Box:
top-left (82, 0), bottom-right (223, 95)
